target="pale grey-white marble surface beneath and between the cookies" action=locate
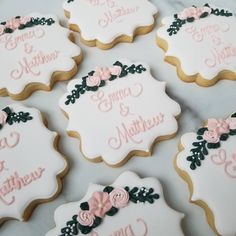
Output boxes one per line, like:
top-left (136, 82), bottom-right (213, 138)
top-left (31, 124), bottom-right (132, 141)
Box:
top-left (0, 0), bottom-right (236, 236)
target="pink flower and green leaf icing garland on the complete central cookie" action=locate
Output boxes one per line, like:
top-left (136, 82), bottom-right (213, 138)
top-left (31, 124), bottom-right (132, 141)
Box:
top-left (65, 61), bottom-right (146, 105)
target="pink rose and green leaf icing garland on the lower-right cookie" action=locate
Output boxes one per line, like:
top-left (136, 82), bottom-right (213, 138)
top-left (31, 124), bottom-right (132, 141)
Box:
top-left (187, 113), bottom-right (236, 170)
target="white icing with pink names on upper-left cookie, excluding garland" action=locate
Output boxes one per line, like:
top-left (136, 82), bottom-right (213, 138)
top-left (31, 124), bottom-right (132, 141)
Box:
top-left (0, 13), bottom-right (81, 94)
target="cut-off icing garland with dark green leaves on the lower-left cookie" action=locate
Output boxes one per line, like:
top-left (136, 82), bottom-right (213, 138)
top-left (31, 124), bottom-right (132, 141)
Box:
top-left (0, 107), bottom-right (33, 129)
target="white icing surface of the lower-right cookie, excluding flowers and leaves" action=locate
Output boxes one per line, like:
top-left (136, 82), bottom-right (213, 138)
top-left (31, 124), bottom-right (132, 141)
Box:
top-left (177, 115), bottom-right (236, 236)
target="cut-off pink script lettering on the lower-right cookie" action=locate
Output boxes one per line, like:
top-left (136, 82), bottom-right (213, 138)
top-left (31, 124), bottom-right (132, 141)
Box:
top-left (210, 148), bottom-right (236, 179)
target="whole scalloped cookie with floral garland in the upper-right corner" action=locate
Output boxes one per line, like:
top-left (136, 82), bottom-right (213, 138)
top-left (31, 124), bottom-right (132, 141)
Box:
top-left (157, 4), bottom-right (236, 86)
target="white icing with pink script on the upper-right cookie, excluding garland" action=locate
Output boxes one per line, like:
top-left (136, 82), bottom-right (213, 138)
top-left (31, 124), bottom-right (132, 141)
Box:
top-left (157, 6), bottom-right (236, 81)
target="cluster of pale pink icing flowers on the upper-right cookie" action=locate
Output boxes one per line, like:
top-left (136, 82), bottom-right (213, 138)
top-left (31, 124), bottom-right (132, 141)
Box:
top-left (178, 7), bottom-right (212, 20)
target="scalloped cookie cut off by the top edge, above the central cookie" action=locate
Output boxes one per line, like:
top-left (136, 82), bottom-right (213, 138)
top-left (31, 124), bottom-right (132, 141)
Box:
top-left (63, 0), bottom-right (157, 49)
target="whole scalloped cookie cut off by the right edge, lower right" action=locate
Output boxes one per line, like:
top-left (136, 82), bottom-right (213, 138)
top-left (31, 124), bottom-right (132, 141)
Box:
top-left (176, 113), bottom-right (236, 236)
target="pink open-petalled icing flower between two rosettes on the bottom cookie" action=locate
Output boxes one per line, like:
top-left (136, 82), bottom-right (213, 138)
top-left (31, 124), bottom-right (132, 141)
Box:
top-left (88, 192), bottom-right (112, 218)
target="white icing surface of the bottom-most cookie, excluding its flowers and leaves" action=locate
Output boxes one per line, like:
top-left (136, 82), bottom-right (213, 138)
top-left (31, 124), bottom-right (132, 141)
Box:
top-left (46, 172), bottom-right (184, 236)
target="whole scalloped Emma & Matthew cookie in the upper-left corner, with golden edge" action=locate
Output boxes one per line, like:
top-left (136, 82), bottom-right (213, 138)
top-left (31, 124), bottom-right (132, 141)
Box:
top-left (0, 13), bottom-right (81, 100)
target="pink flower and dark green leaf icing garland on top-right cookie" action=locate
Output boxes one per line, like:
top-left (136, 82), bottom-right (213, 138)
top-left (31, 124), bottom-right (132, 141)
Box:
top-left (167, 4), bottom-right (233, 36)
